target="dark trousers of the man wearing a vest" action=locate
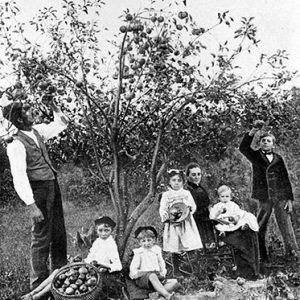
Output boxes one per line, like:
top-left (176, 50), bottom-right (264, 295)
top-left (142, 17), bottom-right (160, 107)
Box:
top-left (30, 180), bottom-right (67, 290)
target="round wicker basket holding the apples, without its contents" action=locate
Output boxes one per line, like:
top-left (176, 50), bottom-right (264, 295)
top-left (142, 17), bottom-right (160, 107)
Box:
top-left (51, 262), bottom-right (102, 300)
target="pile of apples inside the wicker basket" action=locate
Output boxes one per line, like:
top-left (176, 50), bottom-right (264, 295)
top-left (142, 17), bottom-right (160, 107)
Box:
top-left (53, 265), bottom-right (98, 295)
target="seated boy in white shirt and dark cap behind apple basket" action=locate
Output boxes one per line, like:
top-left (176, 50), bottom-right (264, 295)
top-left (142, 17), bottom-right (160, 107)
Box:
top-left (21, 216), bottom-right (122, 300)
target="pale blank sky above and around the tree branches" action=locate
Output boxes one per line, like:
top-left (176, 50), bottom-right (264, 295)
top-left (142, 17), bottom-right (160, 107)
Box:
top-left (0, 0), bottom-right (300, 87)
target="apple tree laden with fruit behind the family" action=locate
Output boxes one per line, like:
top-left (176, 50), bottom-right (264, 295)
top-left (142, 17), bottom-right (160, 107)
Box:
top-left (0, 0), bottom-right (299, 253)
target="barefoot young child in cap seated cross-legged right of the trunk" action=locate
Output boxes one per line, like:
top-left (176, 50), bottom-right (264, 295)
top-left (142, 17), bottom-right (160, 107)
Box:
top-left (129, 226), bottom-right (179, 300)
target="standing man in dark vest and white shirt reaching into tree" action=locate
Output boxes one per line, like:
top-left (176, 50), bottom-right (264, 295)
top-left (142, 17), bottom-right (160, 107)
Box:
top-left (3, 102), bottom-right (67, 290)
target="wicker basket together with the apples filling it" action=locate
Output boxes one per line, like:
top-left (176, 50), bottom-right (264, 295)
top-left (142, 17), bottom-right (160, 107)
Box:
top-left (51, 262), bottom-right (102, 300)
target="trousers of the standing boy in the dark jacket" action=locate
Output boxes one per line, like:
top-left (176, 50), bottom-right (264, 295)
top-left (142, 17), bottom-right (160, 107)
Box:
top-left (257, 201), bottom-right (298, 260)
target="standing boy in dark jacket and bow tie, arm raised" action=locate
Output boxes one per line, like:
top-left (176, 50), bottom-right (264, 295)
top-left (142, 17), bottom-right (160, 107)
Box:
top-left (240, 121), bottom-right (298, 261)
